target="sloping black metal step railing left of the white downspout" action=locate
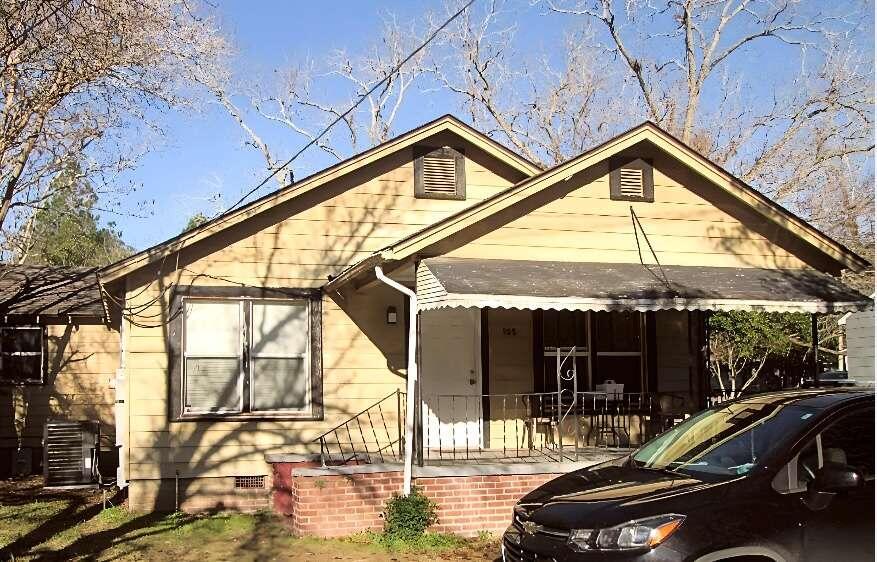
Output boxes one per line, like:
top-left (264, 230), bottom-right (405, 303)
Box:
top-left (313, 390), bottom-right (405, 466)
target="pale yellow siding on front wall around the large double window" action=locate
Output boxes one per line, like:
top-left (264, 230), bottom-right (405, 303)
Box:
top-left (125, 149), bottom-right (514, 486)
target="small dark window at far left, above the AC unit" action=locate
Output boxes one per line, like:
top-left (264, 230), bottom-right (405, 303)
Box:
top-left (0, 326), bottom-right (45, 384)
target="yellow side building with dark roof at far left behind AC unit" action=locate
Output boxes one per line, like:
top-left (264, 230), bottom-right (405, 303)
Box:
top-left (0, 265), bottom-right (119, 477)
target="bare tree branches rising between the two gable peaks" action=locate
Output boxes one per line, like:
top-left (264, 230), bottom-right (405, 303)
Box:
top-left (430, 0), bottom-right (631, 165)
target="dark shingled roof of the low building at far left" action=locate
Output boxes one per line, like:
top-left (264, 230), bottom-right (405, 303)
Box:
top-left (0, 265), bottom-right (106, 323)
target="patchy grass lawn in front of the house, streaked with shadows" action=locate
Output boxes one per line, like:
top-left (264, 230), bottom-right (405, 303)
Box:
top-left (0, 479), bottom-right (499, 562)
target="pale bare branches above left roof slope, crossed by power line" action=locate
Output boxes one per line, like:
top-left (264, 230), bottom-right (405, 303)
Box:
top-left (212, 15), bottom-right (426, 187)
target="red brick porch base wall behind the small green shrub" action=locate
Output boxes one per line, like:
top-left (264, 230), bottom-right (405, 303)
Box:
top-left (274, 465), bottom-right (559, 537)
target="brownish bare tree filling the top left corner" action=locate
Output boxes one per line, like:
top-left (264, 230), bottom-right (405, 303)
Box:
top-left (0, 0), bottom-right (226, 258)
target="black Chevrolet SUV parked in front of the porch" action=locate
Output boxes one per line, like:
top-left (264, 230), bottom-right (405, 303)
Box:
top-left (502, 389), bottom-right (875, 562)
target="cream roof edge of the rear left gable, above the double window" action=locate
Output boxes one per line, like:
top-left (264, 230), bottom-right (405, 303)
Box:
top-left (99, 115), bottom-right (541, 283)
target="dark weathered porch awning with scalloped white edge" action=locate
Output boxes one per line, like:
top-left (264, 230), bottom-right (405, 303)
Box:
top-left (417, 258), bottom-right (872, 312)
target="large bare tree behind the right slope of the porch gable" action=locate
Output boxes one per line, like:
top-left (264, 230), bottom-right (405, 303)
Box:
top-left (545, 0), bottom-right (874, 268)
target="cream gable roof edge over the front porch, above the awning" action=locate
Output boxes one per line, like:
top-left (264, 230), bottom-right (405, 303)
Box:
top-left (381, 121), bottom-right (870, 271)
